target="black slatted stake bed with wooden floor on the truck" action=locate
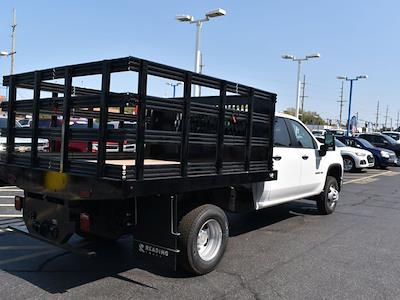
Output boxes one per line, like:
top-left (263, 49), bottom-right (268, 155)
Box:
top-left (0, 57), bottom-right (276, 199)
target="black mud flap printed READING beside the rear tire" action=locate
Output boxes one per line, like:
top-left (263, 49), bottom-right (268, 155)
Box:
top-left (133, 195), bottom-right (179, 270)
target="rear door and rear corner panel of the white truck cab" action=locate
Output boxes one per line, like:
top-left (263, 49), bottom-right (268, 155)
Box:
top-left (253, 117), bottom-right (300, 209)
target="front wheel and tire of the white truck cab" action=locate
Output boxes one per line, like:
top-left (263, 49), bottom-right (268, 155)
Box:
top-left (317, 176), bottom-right (339, 215)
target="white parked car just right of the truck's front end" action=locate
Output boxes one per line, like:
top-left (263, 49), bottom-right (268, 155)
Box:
top-left (318, 138), bottom-right (375, 172)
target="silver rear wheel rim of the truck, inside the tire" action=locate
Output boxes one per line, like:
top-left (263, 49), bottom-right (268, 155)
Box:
top-left (197, 219), bottom-right (222, 261)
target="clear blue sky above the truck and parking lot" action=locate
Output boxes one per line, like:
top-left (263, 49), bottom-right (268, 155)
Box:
top-left (0, 0), bottom-right (400, 126)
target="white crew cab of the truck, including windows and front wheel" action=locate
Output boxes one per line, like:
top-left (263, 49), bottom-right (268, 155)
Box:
top-left (253, 113), bottom-right (343, 214)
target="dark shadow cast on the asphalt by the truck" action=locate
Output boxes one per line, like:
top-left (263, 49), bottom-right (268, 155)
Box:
top-left (0, 201), bottom-right (317, 294)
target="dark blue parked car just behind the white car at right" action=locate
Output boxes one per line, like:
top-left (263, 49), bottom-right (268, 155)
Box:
top-left (336, 136), bottom-right (398, 169)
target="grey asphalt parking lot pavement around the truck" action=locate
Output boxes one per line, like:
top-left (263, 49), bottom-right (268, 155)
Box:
top-left (0, 168), bottom-right (400, 299)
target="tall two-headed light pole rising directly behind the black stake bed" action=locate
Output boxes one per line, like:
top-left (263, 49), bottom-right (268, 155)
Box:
top-left (175, 8), bottom-right (226, 96)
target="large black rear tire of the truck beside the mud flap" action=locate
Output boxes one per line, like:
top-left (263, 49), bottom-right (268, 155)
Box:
top-left (178, 204), bottom-right (229, 275)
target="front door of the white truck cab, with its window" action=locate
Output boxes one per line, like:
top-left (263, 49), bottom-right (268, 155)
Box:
top-left (286, 119), bottom-right (326, 194)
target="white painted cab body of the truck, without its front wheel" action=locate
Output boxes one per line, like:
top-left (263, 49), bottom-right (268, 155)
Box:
top-left (253, 113), bottom-right (343, 209)
